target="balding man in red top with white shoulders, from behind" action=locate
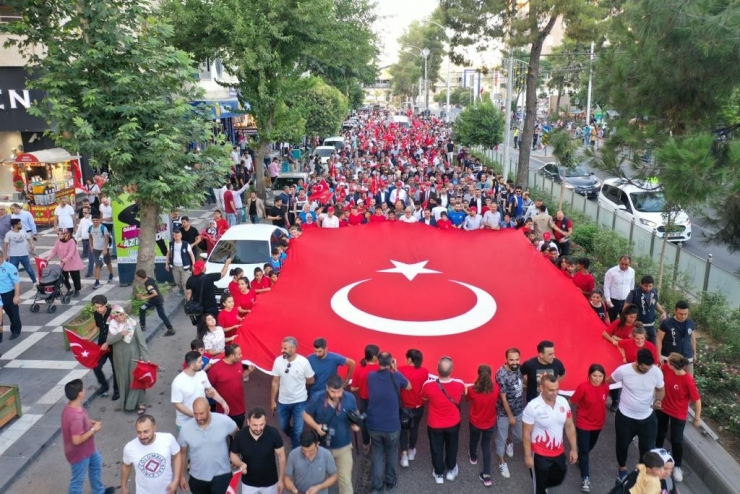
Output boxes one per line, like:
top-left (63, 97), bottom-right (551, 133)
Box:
top-left (421, 357), bottom-right (466, 484)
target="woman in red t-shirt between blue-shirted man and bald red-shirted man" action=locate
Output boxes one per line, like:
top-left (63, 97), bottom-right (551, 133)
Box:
top-left (397, 348), bottom-right (429, 468)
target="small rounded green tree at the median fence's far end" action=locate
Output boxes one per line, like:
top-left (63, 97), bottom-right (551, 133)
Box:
top-left (452, 101), bottom-right (504, 148)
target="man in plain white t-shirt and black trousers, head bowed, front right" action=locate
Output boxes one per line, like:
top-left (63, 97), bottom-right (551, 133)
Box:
top-left (607, 348), bottom-right (665, 480)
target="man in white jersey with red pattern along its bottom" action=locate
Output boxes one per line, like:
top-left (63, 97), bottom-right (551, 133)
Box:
top-left (522, 374), bottom-right (578, 494)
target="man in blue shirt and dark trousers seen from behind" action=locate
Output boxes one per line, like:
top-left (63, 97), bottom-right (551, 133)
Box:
top-left (366, 352), bottom-right (410, 494)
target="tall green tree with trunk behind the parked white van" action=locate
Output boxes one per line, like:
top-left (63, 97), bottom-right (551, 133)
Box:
top-left (164, 0), bottom-right (376, 197)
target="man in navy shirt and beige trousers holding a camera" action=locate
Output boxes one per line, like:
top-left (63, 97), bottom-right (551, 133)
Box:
top-left (303, 374), bottom-right (360, 494)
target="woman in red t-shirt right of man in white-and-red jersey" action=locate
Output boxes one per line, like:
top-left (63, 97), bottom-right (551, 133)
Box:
top-left (570, 364), bottom-right (609, 490)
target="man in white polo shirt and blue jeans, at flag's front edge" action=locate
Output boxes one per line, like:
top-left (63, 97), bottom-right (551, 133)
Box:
top-left (270, 336), bottom-right (315, 449)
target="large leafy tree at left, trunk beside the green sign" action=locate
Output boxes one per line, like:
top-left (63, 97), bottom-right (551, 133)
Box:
top-left (0, 0), bottom-right (228, 273)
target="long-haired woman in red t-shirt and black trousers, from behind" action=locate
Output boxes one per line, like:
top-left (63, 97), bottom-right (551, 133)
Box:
top-left (465, 364), bottom-right (501, 487)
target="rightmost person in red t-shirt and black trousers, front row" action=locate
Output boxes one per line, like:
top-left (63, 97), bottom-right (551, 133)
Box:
top-left (655, 352), bottom-right (701, 474)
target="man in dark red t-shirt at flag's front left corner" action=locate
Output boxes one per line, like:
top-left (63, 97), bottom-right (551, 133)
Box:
top-left (208, 343), bottom-right (250, 429)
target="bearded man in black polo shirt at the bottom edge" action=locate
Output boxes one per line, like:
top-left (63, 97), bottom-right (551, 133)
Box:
top-left (230, 407), bottom-right (286, 492)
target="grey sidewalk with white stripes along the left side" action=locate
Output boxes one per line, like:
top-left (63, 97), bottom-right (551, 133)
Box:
top-left (0, 206), bottom-right (211, 492)
